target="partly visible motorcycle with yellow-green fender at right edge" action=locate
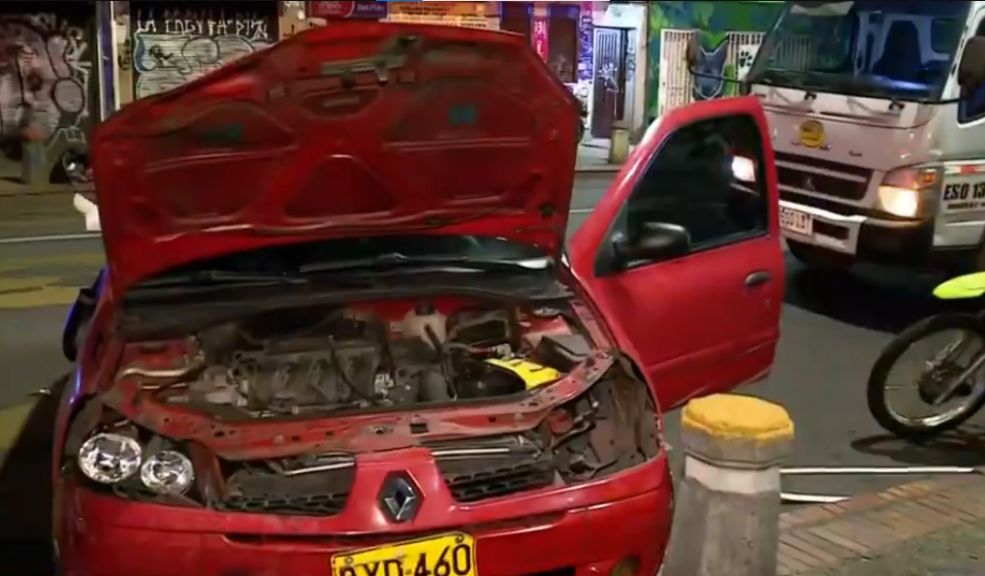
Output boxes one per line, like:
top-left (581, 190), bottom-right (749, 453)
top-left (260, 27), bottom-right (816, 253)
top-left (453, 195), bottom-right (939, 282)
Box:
top-left (867, 272), bottom-right (985, 441)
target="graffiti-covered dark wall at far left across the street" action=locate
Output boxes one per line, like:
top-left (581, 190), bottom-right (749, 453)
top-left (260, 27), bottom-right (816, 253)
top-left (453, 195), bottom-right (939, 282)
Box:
top-left (0, 2), bottom-right (98, 182)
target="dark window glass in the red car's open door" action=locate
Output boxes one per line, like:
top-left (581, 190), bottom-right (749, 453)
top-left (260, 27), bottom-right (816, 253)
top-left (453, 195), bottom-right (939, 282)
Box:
top-left (624, 115), bottom-right (769, 252)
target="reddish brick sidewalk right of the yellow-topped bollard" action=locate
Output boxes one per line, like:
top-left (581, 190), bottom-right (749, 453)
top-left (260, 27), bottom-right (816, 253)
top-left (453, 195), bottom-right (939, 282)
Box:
top-left (777, 474), bottom-right (985, 576)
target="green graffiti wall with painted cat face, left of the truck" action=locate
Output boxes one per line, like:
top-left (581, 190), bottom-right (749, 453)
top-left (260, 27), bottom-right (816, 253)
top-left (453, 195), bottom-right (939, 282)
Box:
top-left (646, 1), bottom-right (783, 118)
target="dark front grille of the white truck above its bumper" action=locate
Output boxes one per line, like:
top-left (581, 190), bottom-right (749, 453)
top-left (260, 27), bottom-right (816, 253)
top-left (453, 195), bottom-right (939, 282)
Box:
top-left (776, 152), bottom-right (872, 201)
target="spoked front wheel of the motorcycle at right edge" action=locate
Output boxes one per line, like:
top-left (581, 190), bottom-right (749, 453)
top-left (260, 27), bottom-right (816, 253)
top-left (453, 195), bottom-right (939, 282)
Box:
top-left (867, 314), bottom-right (985, 441)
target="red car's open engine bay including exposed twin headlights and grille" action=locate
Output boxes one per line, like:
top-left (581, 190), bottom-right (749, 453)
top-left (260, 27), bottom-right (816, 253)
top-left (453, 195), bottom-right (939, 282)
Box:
top-left (63, 298), bottom-right (661, 508)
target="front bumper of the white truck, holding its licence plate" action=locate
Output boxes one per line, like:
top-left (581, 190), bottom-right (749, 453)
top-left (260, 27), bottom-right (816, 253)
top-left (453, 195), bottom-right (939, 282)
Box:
top-left (780, 200), bottom-right (975, 268)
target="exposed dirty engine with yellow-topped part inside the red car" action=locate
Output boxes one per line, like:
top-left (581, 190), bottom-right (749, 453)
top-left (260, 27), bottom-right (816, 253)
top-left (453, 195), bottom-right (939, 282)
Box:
top-left (141, 302), bottom-right (589, 417)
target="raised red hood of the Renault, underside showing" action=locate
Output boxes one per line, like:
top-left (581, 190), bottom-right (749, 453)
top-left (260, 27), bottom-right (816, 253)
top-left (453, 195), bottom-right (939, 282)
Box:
top-left (92, 22), bottom-right (580, 294)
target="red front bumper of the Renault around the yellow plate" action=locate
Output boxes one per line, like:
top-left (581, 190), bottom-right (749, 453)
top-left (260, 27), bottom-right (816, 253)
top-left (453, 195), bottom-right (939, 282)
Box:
top-left (56, 454), bottom-right (672, 576)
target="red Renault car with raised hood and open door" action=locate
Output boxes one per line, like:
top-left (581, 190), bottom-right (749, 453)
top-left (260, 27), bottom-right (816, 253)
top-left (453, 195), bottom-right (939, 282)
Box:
top-left (54, 22), bottom-right (783, 576)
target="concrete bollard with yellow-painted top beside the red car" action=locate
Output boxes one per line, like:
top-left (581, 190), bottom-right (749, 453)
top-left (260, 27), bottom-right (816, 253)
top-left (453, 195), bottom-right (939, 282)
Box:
top-left (663, 394), bottom-right (794, 576)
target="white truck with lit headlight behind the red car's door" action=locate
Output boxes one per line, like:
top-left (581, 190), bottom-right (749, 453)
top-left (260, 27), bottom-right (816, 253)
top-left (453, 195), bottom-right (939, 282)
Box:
top-left (743, 0), bottom-right (985, 273)
